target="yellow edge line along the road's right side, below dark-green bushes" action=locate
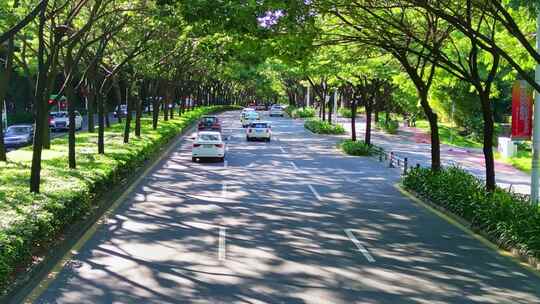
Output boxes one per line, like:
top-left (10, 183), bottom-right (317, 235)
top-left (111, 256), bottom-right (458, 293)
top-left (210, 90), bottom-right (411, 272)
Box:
top-left (394, 183), bottom-right (540, 278)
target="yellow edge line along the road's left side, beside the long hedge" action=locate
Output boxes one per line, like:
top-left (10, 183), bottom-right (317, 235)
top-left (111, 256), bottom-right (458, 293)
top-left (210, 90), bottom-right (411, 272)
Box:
top-left (23, 127), bottom-right (193, 303)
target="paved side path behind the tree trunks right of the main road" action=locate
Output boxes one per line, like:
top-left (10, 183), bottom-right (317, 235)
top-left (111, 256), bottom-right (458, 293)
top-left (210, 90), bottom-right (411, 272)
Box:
top-left (338, 117), bottom-right (531, 194)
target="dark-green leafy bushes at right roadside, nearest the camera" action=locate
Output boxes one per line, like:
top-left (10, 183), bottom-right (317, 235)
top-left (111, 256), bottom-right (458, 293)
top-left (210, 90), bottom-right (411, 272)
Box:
top-left (403, 168), bottom-right (540, 267)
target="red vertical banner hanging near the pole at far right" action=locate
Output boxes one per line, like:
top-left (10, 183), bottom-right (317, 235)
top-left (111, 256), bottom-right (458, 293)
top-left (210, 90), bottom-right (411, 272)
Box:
top-left (512, 80), bottom-right (533, 140)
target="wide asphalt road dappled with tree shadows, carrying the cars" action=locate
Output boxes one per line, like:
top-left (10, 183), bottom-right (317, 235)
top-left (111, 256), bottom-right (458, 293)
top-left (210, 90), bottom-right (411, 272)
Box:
top-left (28, 112), bottom-right (540, 304)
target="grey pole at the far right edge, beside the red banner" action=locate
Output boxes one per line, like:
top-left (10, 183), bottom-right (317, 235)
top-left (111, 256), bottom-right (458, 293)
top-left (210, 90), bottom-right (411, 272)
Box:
top-left (531, 12), bottom-right (540, 203)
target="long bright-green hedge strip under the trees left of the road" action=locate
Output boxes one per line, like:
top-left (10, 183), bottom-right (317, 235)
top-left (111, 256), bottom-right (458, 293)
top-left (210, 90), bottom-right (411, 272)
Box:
top-left (0, 106), bottom-right (238, 295)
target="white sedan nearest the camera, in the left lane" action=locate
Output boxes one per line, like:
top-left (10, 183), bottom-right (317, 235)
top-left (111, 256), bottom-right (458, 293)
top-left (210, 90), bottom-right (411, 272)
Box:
top-left (191, 131), bottom-right (225, 162)
